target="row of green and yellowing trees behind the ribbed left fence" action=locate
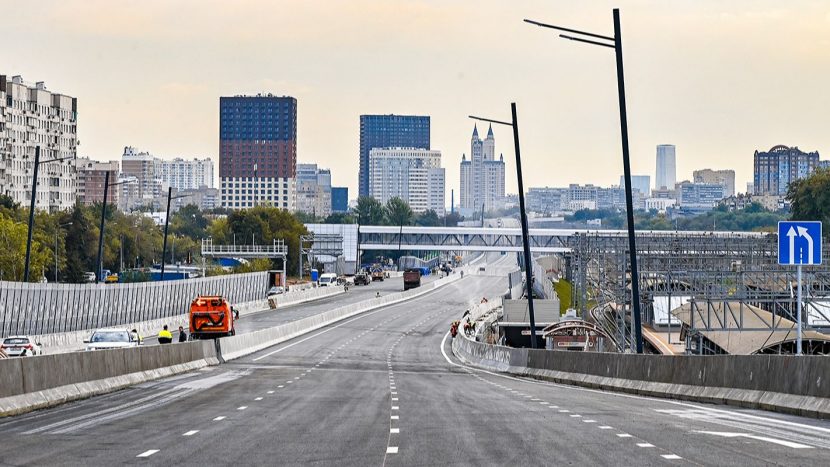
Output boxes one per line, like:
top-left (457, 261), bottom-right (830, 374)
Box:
top-left (0, 196), bottom-right (307, 282)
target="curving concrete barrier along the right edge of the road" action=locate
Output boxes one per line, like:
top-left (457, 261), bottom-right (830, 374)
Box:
top-left (452, 334), bottom-right (830, 418)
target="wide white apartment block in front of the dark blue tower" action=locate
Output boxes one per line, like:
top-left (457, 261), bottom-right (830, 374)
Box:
top-left (369, 148), bottom-right (446, 215)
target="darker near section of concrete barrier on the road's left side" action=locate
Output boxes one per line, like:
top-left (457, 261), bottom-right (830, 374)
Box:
top-left (0, 341), bottom-right (219, 416)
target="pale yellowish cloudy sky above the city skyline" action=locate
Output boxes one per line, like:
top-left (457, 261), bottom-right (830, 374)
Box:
top-left (0, 0), bottom-right (830, 201)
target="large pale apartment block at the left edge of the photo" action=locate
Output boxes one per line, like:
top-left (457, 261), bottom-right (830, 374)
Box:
top-left (0, 75), bottom-right (78, 210)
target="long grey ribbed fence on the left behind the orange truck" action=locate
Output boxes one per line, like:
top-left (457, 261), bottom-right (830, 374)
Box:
top-left (0, 272), bottom-right (268, 336)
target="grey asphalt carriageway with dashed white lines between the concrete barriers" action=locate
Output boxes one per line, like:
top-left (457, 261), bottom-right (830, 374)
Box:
top-left (0, 276), bottom-right (830, 466)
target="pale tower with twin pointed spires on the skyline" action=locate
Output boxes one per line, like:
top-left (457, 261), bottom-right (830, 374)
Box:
top-left (459, 126), bottom-right (505, 212)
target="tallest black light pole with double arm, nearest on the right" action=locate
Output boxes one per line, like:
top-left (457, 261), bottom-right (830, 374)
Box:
top-left (520, 8), bottom-right (643, 353)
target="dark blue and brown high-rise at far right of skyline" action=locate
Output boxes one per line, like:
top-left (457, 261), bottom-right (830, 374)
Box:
top-left (754, 145), bottom-right (819, 196)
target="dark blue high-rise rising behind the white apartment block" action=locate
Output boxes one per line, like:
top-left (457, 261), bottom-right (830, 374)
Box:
top-left (358, 115), bottom-right (430, 196)
